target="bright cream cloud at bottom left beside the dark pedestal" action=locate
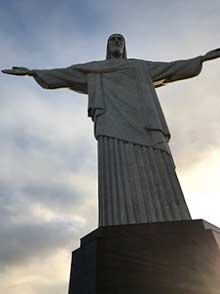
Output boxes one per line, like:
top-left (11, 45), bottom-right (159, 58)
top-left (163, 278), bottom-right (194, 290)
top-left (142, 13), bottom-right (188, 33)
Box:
top-left (0, 250), bottom-right (70, 294)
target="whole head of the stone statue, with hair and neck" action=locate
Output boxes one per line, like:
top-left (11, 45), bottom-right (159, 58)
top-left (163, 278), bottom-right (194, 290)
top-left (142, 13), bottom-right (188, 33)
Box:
top-left (106, 34), bottom-right (127, 59)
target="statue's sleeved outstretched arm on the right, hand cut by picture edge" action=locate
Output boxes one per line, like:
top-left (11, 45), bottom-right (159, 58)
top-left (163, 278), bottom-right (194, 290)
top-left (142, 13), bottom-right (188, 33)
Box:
top-left (147, 49), bottom-right (220, 87)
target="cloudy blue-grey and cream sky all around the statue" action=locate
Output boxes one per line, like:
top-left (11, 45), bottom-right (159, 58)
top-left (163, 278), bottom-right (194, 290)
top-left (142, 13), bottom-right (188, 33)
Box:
top-left (0, 0), bottom-right (220, 294)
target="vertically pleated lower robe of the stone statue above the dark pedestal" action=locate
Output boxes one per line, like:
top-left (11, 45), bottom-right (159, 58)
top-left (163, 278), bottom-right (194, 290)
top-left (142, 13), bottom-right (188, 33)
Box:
top-left (98, 136), bottom-right (191, 226)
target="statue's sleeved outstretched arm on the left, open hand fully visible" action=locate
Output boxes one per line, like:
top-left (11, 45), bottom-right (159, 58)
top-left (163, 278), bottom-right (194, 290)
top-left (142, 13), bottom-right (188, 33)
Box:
top-left (2, 66), bottom-right (87, 94)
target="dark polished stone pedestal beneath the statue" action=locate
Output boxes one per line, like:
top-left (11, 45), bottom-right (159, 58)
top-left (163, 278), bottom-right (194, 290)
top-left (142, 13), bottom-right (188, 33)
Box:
top-left (69, 220), bottom-right (220, 294)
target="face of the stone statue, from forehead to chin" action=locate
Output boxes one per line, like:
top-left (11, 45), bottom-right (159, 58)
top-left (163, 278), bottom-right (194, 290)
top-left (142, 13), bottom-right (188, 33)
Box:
top-left (108, 34), bottom-right (125, 58)
